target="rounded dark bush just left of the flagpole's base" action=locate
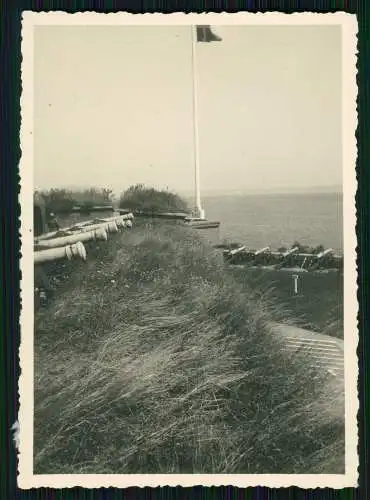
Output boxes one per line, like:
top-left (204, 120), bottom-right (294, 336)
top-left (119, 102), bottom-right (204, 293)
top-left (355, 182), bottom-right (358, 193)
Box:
top-left (119, 184), bottom-right (190, 213)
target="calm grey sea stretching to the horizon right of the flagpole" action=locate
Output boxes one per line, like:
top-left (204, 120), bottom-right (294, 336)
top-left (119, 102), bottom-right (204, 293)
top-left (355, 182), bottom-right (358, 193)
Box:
top-left (202, 193), bottom-right (343, 253)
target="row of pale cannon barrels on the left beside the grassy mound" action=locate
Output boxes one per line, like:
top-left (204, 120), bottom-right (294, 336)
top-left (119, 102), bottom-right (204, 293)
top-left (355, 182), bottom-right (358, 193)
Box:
top-left (34, 214), bottom-right (133, 264)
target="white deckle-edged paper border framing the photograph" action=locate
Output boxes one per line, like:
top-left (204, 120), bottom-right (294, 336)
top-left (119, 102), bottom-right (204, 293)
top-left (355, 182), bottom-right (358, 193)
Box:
top-left (18, 11), bottom-right (359, 489)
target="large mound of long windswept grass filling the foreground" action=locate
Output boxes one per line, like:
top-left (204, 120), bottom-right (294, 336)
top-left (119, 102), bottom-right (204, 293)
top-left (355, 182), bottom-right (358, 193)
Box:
top-left (34, 222), bottom-right (344, 473)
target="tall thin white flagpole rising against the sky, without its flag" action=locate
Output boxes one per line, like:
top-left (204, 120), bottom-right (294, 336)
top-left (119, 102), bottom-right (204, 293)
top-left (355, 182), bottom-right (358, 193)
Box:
top-left (191, 26), bottom-right (205, 219)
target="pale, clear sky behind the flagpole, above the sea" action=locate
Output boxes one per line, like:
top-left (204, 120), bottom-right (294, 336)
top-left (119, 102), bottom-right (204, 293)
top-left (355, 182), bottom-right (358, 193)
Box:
top-left (34, 25), bottom-right (342, 194)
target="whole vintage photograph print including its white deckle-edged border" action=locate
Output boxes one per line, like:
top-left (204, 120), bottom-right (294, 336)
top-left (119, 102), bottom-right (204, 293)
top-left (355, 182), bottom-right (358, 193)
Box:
top-left (19, 12), bottom-right (358, 488)
